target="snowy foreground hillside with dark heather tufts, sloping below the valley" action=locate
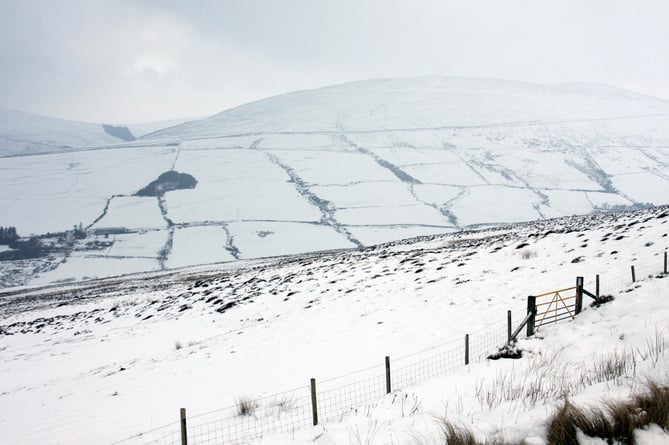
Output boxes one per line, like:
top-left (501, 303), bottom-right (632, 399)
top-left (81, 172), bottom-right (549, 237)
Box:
top-left (0, 207), bottom-right (669, 445)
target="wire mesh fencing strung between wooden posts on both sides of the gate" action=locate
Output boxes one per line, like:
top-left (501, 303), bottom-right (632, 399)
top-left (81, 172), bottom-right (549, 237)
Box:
top-left (121, 248), bottom-right (667, 445)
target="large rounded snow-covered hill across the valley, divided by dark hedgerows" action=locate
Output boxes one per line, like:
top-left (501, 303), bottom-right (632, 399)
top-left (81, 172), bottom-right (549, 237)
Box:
top-left (0, 77), bottom-right (669, 286)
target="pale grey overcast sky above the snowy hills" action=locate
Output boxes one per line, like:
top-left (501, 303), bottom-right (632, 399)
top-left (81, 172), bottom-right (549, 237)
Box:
top-left (0, 0), bottom-right (669, 123)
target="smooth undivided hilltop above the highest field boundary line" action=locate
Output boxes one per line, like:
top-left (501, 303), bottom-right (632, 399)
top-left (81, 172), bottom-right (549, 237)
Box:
top-left (145, 77), bottom-right (669, 139)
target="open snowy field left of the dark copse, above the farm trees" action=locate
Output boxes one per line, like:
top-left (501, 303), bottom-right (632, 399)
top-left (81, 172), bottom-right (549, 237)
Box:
top-left (0, 146), bottom-right (176, 236)
